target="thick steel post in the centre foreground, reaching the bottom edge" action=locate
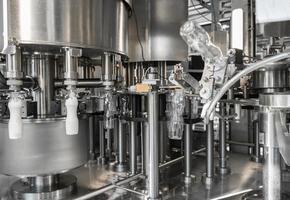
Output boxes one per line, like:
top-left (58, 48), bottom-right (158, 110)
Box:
top-left (147, 91), bottom-right (159, 199)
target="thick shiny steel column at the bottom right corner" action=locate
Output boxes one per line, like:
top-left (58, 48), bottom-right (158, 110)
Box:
top-left (259, 111), bottom-right (281, 200)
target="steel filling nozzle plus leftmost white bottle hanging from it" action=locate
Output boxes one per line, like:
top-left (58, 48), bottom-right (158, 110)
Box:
top-left (2, 45), bottom-right (23, 140)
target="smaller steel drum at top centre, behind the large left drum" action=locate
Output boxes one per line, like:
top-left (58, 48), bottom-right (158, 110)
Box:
top-left (129, 0), bottom-right (188, 62)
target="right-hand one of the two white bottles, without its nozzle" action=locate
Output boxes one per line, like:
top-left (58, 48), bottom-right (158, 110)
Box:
top-left (65, 91), bottom-right (79, 135)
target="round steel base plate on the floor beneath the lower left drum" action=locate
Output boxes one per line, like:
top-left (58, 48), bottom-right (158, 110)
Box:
top-left (11, 175), bottom-right (77, 200)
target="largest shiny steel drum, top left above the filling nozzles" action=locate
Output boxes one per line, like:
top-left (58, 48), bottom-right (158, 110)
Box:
top-left (0, 0), bottom-right (130, 55)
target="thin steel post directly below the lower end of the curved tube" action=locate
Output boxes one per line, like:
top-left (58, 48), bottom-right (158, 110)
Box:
top-left (206, 120), bottom-right (214, 183)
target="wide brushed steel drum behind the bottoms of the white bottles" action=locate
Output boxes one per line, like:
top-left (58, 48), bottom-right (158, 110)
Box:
top-left (0, 119), bottom-right (89, 176)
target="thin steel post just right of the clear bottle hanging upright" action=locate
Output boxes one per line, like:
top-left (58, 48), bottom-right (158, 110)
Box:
top-left (184, 124), bottom-right (192, 184)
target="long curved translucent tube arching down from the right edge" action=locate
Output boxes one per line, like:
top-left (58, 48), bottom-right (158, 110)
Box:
top-left (204, 52), bottom-right (290, 123)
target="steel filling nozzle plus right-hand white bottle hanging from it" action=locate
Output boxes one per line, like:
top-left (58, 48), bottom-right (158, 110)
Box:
top-left (64, 47), bottom-right (82, 135)
